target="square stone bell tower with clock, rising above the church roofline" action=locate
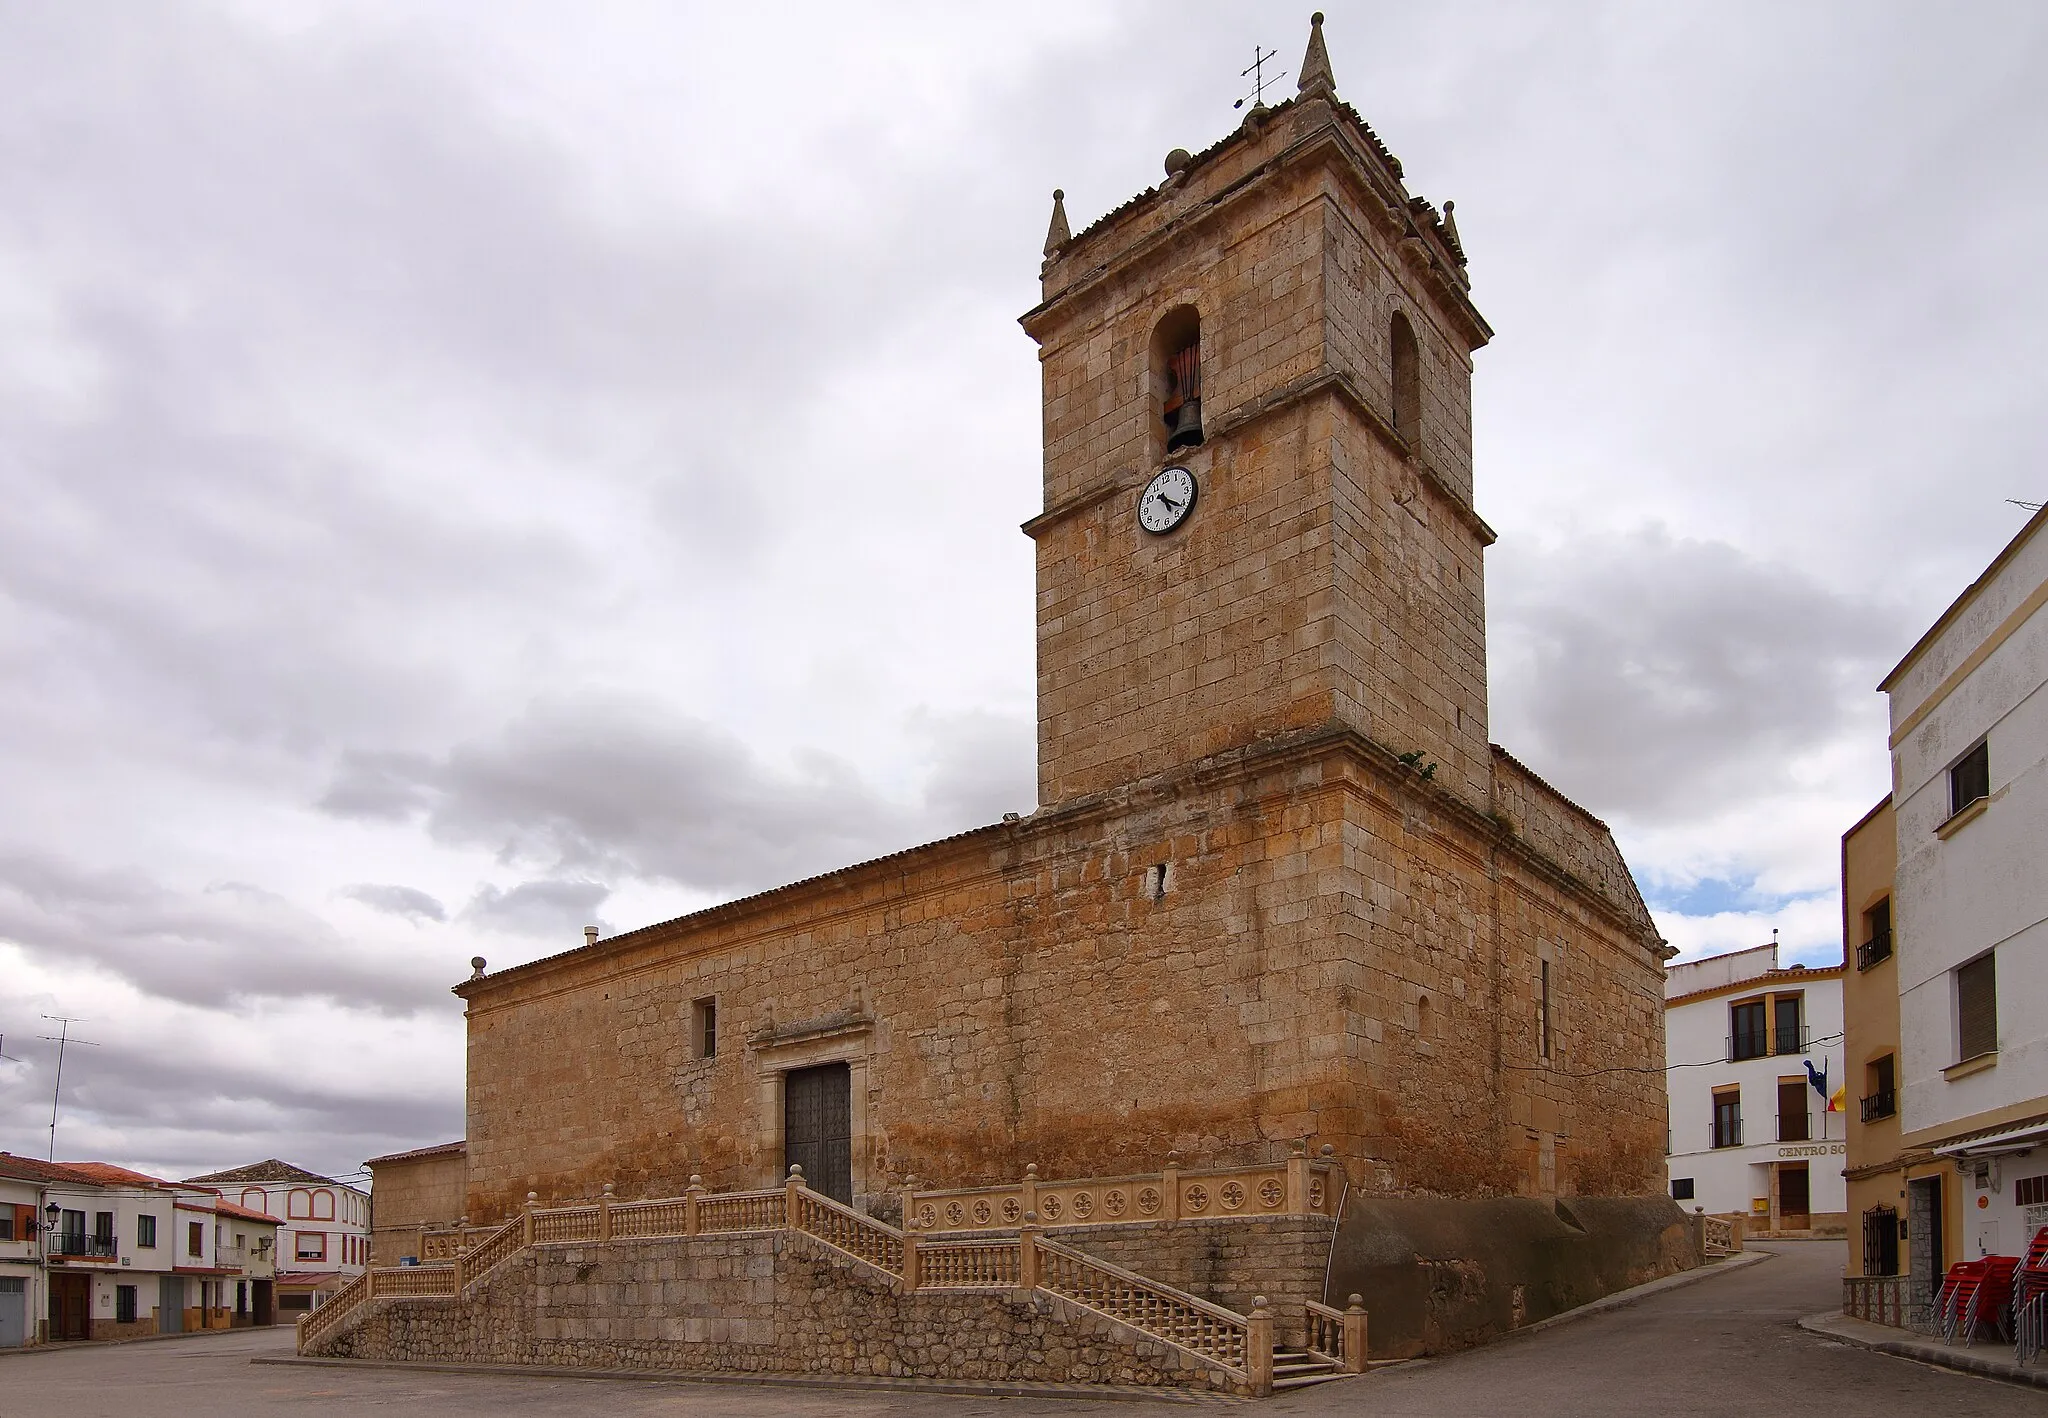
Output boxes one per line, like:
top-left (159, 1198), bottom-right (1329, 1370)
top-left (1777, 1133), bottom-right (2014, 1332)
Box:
top-left (1022, 14), bottom-right (1493, 809)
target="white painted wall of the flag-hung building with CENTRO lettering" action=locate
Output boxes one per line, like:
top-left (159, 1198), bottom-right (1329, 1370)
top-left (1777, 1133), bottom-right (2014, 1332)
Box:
top-left (1665, 947), bottom-right (1855, 1215)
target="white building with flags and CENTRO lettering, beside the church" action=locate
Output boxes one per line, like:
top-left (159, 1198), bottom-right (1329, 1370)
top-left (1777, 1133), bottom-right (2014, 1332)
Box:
top-left (1665, 945), bottom-right (1849, 1234)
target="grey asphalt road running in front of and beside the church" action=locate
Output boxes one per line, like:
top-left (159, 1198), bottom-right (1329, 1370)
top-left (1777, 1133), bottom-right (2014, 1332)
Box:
top-left (0, 1242), bottom-right (2048, 1418)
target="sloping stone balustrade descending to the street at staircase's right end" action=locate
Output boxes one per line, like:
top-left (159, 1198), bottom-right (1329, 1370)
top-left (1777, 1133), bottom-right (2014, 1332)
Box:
top-left (1018, 1227), bottom-right (1274, 1387)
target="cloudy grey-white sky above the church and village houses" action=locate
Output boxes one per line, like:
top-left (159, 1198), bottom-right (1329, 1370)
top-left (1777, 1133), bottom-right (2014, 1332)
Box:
top-left (0, 0), bottom-right (2048, 1174)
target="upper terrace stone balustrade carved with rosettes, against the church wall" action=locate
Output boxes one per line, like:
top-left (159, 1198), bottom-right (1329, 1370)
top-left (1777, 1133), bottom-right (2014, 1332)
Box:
top-left (903, 1145), bottom-right (1343, 1232)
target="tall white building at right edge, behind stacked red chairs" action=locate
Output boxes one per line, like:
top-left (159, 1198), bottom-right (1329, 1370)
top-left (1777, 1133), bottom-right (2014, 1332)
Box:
top-left (1880, 512), bottom-right (2048, 1268)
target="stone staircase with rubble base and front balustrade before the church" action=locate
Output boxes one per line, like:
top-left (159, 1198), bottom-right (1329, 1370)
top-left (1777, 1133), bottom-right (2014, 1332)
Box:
top-left (299, 1168), bottom-right (1366, 1398)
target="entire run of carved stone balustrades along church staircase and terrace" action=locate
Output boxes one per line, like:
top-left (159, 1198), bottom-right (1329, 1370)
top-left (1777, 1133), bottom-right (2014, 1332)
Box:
top-left (299, 1152), bottom-right (1366, 1393)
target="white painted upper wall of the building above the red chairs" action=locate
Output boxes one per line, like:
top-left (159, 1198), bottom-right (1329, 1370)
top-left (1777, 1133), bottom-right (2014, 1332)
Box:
top-left (1890, 527), bottom-right (2048, 1139)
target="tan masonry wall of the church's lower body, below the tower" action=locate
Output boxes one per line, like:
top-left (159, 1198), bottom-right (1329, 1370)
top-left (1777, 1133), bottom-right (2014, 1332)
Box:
top-left (463, 736), bottom-right (1663, 1223)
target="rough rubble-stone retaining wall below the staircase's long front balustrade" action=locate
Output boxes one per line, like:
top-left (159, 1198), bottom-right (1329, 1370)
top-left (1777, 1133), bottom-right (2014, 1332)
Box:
top-left (311, 1232), bottom-right (1235, 1391)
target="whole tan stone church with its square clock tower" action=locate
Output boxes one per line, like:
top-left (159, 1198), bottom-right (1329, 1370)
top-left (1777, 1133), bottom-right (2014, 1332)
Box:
top-left (339, 16), bottom-right (1698, 1377)
